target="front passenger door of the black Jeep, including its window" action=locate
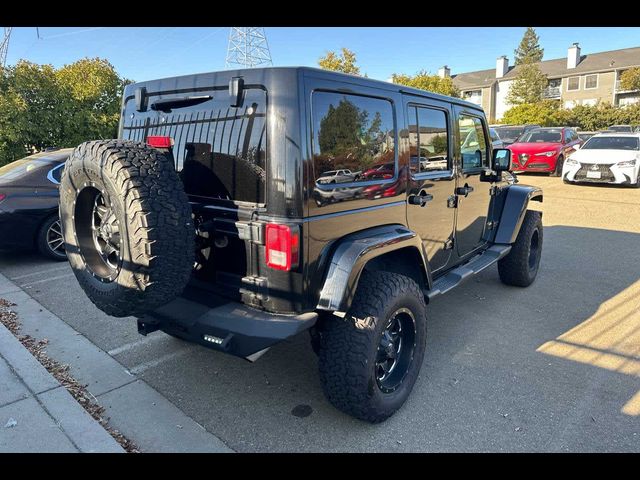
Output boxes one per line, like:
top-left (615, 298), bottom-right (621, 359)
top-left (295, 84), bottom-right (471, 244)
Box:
top-left (456, 107), bottom-right (491, 257)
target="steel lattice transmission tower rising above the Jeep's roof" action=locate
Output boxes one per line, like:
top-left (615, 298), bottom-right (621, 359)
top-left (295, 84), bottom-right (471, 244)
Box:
top-left (226, 27), bottom-right (273, 68)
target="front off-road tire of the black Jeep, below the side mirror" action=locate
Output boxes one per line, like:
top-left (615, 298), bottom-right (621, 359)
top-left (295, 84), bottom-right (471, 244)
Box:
top-left (498, 210), bottom-right (543, 287)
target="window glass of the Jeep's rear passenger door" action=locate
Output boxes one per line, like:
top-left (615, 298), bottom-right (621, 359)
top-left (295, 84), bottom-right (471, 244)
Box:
top-left (409, 107), bottom-right (449, 173)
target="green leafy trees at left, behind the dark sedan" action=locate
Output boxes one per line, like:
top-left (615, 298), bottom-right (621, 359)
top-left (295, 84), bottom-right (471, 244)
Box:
top-left (0, 58), bottom-right (128, 165)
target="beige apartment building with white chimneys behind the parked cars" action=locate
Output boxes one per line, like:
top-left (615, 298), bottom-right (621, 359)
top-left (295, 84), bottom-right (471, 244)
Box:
top-left (448, 43), bottom-right (640, 122)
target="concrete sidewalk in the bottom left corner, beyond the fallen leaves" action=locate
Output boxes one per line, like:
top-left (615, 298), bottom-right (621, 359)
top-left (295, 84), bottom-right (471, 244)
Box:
top-left (0, 279), bottom-right (124, 453)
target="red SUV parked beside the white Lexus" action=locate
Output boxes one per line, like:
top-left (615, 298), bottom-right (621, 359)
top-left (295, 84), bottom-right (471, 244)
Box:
top-left (509, 127), bottom-right (582, 176)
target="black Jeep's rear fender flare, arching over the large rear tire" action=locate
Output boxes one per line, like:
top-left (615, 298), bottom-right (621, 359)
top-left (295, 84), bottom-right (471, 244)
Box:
top-left (316, 224), bottom-right (431, 312)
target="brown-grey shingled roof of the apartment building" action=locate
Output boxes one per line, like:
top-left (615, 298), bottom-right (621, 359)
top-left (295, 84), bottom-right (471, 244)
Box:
top-left (451, 47), bottom-right (640, 89)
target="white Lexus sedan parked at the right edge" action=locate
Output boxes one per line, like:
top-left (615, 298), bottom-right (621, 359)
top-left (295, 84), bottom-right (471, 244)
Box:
top-left (562, 133), bottom-right (640, 188)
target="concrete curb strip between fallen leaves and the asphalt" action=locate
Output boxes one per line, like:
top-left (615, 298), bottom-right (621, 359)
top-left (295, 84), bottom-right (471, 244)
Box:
top-left (0, 274), bottom-right (233, 453)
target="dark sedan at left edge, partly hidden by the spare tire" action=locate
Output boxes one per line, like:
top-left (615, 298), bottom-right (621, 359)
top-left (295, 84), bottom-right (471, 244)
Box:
top-left (0, 148), bottom-right (71, 260)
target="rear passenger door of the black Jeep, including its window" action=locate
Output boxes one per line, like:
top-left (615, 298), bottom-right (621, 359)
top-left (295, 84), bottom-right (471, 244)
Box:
top-left (405, 101), bottom-right (455, 273)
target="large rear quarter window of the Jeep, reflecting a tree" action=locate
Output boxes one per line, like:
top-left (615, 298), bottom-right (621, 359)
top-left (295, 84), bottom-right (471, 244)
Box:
top-left (312, 92), bottom-right (396, 184)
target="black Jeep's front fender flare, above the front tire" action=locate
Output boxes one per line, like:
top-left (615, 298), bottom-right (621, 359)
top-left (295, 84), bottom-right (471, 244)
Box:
top-left (494, 185), bottom-right (543, 245)
